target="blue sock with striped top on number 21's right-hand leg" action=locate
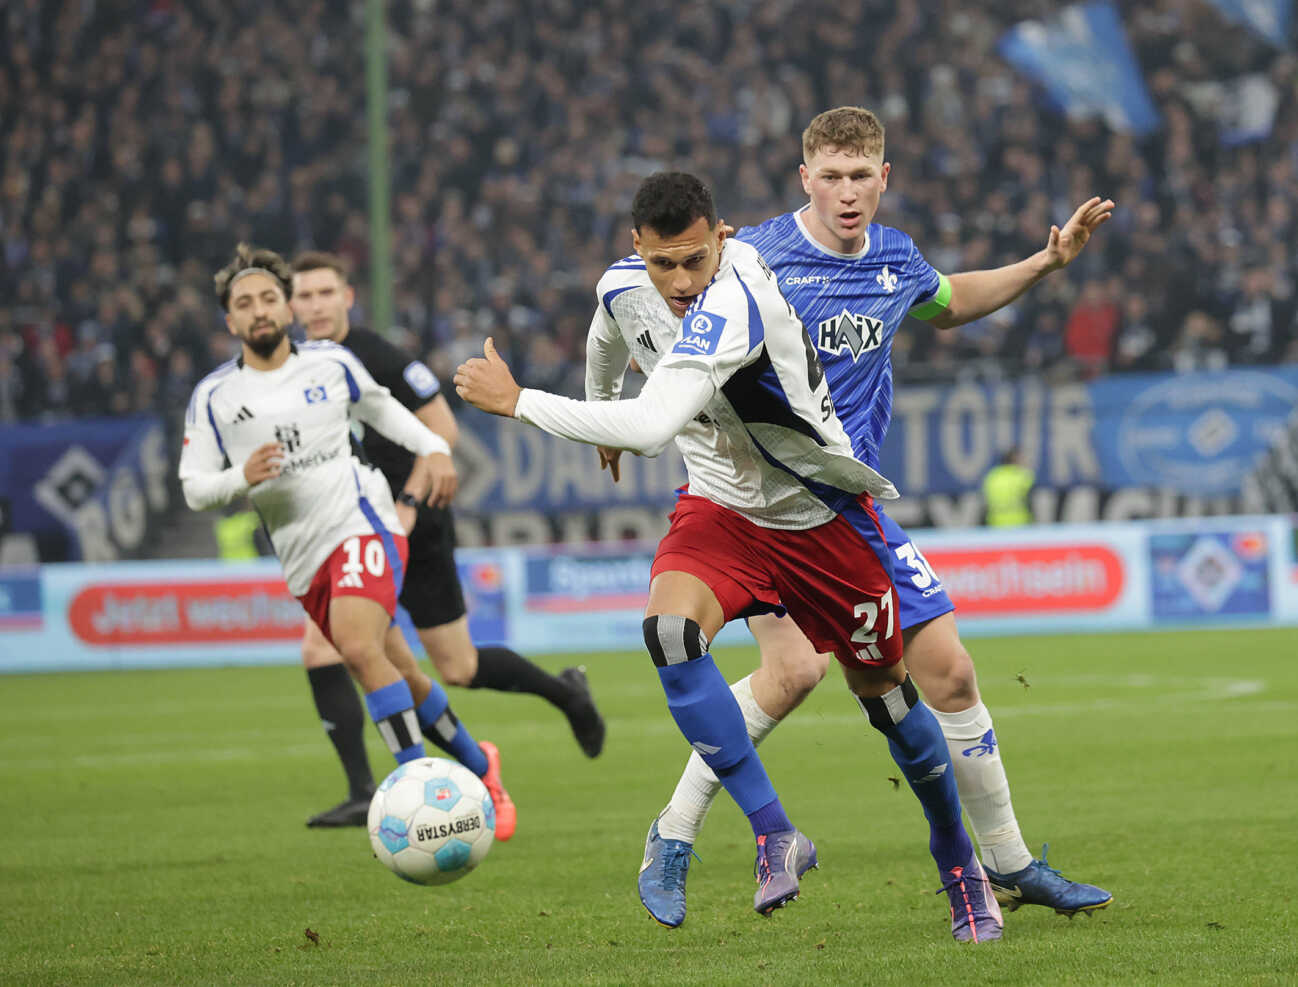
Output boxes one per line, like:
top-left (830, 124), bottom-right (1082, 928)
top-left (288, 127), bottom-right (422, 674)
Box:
top-left (858, 675), bottom-right (974, 871)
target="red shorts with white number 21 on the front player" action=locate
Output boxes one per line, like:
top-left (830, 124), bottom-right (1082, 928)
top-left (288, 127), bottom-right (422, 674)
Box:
top-left (653, 494), bottom-right (902, 668)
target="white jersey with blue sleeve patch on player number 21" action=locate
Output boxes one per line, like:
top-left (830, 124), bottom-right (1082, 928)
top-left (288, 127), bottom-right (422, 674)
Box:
top-left (573, 240), bottom-right (897, 529)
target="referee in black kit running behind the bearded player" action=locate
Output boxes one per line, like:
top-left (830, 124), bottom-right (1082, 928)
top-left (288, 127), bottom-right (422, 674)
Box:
top-left (292, 251), bottom-right (604, 826)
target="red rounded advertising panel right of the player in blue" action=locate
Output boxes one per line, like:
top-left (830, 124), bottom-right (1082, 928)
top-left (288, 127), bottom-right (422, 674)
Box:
top-left (925, 543), bottom-right (1124, 616)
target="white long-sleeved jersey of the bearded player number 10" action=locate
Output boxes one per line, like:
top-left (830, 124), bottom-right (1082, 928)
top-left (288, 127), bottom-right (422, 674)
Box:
top-left (180, 340), bottom-right (448, 596)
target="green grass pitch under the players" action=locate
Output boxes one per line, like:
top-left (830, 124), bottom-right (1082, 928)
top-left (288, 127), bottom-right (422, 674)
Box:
top-left (0, 630), bottom-right (1298, 984)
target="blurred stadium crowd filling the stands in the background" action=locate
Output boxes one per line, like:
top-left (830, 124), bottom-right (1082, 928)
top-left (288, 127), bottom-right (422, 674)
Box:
top-left (0, 0), bottom-right (1298, 421)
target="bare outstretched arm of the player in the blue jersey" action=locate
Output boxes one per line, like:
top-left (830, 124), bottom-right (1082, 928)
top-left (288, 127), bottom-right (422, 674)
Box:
top-left (929, 196), bottom-right (1114, 329)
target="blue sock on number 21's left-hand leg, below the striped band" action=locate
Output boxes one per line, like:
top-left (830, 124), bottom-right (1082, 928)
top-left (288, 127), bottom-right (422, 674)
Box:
top-left (658, 652), bottom-right (793, 835)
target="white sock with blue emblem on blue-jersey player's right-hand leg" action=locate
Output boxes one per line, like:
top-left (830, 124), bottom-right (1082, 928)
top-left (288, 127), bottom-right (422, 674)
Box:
top-left (933, 703), bottom-right (1032, 874)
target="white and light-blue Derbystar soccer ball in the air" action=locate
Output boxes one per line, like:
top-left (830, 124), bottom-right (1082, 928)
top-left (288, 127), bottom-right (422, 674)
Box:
top-left (369, 757), bottom-right (496, 884)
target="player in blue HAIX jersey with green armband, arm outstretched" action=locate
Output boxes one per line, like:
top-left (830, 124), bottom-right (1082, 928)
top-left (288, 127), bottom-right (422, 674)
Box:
top-left (639, 106), bottom-right (1114, 919)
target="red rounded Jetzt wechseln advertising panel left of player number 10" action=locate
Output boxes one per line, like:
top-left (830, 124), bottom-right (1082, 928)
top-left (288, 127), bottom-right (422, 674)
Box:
top-left (67, 579), bottom-right (305, 645)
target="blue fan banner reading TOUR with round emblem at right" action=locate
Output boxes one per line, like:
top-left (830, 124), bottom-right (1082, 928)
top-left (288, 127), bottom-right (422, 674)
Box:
top-left (880, 366), bottom-right (1298, 497)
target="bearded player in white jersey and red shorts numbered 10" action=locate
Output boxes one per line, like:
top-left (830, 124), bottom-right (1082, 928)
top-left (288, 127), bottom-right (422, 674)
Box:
top-left (180, 244), bottom-right (513, 839)
